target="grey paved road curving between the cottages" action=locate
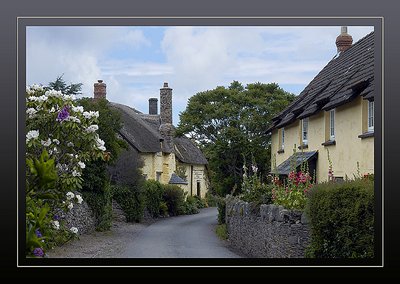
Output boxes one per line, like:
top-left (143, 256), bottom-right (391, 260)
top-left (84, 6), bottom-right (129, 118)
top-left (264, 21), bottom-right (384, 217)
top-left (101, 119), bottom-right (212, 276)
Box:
top-left (122, 207), bottom-right (240, 258)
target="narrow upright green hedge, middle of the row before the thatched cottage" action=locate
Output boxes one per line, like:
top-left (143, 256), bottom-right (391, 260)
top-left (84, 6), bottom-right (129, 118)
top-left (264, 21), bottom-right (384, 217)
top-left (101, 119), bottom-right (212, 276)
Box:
top-left (144, 180), bottom-right (164, 217)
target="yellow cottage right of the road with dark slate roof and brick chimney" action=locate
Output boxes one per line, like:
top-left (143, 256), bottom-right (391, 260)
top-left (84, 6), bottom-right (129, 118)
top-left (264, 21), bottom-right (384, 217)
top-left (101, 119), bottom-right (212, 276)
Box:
top-left (267, 27), bottom-right (375, 182)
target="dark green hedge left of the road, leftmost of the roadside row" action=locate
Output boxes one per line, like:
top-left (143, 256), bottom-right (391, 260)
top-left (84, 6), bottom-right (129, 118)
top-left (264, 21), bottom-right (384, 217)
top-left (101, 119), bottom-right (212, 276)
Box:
top-left (113, 185), bottom-right (145, 222)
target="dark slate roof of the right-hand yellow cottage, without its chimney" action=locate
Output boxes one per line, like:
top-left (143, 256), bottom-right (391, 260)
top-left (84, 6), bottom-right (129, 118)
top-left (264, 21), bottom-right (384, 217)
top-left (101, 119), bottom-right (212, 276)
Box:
top-left (266, 32), bottom-right (374, 133)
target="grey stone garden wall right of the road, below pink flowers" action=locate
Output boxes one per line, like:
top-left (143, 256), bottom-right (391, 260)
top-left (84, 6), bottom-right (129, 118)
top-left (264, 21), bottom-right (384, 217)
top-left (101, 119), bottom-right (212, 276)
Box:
top-left (226, 197), bottom-right (310, 258)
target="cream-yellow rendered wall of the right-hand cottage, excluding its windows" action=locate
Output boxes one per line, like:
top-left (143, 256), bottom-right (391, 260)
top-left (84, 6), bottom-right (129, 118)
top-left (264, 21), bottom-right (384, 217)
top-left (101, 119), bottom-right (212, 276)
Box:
top-left (271, 97), bottom-right (374, 182)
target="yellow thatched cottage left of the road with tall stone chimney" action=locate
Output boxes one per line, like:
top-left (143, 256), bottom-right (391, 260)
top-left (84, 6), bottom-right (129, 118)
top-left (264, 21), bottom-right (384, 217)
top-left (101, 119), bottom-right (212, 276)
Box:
top-left (94, 80), bottom-right (209, 197)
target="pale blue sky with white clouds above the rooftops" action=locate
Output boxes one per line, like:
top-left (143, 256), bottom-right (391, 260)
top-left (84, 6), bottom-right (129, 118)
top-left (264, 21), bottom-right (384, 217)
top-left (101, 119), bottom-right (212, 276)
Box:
top-left (26, 26), bottom-right (373, 124)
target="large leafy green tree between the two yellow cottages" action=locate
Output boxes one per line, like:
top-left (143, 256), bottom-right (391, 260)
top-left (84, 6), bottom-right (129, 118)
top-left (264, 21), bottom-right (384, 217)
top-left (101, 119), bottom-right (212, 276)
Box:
top-left (176, 81), bottom-right (294, 195)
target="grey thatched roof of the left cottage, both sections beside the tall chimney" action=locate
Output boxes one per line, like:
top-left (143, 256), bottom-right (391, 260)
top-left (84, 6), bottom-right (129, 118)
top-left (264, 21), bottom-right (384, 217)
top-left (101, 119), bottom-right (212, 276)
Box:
top-left (109, 102), bottom-right (208, 165)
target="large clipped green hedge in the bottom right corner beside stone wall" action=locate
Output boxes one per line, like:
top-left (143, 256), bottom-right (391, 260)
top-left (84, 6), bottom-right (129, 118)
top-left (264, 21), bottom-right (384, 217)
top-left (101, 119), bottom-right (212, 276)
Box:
top-left (306, 179), bottom-right (374, 258)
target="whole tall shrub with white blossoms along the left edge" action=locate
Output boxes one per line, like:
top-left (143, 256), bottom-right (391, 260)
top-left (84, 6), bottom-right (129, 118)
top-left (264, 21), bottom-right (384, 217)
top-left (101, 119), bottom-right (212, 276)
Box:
top-left (25, 85), bottom-right (108, 257)
